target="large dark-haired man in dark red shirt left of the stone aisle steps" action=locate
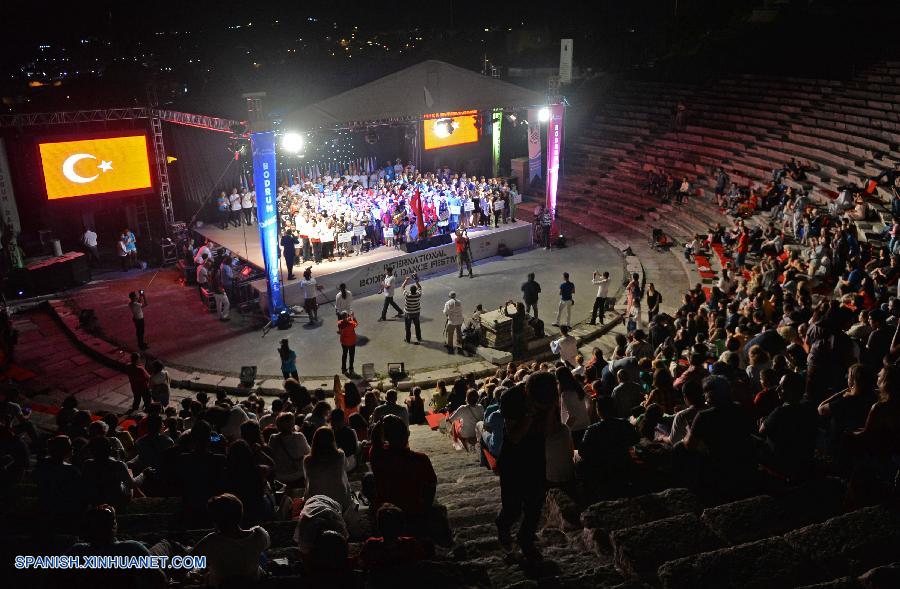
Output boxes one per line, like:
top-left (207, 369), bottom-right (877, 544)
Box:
top-left (363, 415), bottom-right (437, 532)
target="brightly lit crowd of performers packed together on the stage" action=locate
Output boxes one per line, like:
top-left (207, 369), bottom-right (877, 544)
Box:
top-left (278, 164), bottom-right (521, 264)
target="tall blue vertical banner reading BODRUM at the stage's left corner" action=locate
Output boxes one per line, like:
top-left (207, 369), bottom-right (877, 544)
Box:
top-left (250, 131), bottom-right (284, 321)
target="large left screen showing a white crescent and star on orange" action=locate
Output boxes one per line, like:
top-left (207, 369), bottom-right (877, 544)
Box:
top-left (38, 134), bottom-right (153, 200)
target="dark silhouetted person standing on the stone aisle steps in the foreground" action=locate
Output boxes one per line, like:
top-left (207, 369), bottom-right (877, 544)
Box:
top-left (496, 372), bottom-right (558, 561)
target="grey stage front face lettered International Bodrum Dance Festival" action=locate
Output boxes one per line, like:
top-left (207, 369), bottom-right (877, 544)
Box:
top-left (253, 222), bottom-right (532, 311)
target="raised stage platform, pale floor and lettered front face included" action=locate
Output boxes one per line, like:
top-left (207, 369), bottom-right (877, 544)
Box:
top-left (195, 221), bottom-right (532, 310)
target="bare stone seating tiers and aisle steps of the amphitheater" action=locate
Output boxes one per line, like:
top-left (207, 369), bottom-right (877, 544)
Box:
top-left (2, 63), bottom-right (900, 589)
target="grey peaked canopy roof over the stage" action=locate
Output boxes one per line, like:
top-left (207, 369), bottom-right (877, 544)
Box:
top-left (284, 60), bottom-right (547, 130)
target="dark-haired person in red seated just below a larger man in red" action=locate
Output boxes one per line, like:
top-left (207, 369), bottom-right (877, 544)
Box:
top-left (359, 503), bottom-right (433, 571)
